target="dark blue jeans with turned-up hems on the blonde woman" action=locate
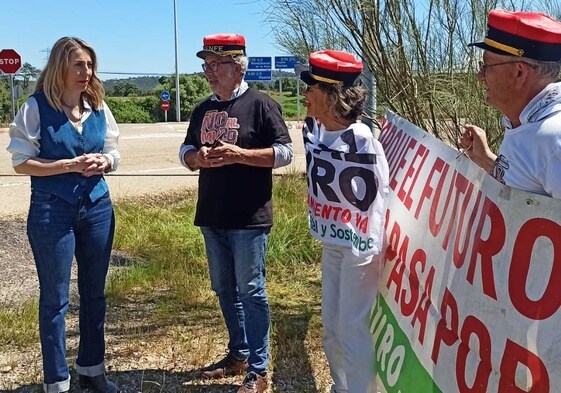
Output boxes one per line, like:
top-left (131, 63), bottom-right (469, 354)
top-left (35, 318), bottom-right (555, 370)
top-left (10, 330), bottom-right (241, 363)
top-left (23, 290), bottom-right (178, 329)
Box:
top-left (27, 190), bottom-right (115, 391)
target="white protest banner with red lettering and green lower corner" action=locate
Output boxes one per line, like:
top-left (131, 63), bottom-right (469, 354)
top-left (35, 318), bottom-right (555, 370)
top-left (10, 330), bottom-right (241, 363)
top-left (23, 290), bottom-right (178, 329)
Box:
top-left (373, 113), bottom-right (561, 393)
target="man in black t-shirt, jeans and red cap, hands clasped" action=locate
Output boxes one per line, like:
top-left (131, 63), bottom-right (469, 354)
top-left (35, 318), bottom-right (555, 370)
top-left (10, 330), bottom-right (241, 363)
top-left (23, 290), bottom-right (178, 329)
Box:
top-left (179, 34), bottom-right (292, 393)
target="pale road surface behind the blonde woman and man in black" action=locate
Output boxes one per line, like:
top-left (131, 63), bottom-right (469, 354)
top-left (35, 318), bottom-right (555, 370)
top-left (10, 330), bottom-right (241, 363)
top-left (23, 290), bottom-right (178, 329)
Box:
top-left (0, 122), bottom-right (305, 217)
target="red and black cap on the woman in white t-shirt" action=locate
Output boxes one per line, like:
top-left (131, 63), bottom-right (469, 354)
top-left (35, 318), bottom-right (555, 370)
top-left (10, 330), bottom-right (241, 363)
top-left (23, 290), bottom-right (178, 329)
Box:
top-left (297, 50), bottom-right (364, 86)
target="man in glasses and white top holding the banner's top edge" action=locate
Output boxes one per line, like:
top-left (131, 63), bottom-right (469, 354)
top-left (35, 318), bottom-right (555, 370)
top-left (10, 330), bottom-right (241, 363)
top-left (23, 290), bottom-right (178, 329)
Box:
top-left (458, 10), bottom-right (561, 198)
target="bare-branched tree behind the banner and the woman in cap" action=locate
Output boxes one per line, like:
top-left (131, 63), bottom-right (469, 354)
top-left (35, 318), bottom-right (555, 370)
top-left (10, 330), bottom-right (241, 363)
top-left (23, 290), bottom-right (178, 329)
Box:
top-left (268, 0), bottom-right (543, 149)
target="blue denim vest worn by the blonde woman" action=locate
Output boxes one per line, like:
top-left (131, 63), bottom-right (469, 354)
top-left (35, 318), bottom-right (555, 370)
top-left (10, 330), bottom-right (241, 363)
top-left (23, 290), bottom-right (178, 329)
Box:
top-left (31, 92), bottom-right (109, 205)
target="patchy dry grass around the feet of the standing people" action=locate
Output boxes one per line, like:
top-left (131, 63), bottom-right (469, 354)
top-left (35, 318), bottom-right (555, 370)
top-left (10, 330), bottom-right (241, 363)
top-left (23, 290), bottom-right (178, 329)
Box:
top-left (0, 176), bottom-right (331, 393)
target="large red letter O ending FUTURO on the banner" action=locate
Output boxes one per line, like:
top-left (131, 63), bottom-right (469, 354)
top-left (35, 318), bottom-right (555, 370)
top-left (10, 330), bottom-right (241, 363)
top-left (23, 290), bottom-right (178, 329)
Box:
top-left (508, 218), bottom-right (561, 320)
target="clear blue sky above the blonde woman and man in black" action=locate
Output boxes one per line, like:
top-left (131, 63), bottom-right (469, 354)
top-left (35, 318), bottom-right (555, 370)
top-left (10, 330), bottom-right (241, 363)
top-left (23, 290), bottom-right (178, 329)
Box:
top-left (0, 0), bottom-right (287, 80)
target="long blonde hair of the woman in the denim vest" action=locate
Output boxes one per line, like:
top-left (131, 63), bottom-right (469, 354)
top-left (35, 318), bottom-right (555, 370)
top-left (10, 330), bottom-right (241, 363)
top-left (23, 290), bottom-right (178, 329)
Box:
top-left (35, 37), bottom-right (105, 111)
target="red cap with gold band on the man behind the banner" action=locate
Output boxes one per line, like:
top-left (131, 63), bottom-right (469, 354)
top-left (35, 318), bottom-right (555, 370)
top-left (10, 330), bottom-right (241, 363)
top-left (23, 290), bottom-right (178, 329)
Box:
top-left (469, 10), bottom-right (561, 62)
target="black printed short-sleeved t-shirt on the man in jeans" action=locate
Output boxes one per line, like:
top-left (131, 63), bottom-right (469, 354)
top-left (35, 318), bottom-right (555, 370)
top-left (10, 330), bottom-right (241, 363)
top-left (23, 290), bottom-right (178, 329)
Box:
top-left (184, 88), bottom-right (291, 229)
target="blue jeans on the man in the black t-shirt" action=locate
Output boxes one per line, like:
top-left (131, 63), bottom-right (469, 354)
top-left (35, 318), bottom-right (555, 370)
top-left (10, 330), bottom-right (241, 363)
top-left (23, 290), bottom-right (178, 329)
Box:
top-left (201, 227), bottom-right (270, 373)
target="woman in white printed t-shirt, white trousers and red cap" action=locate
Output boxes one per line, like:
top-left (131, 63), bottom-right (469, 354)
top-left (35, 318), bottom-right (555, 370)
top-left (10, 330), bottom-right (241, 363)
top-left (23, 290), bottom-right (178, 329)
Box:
top-left (297, 50), bottom-right (389, 393)
